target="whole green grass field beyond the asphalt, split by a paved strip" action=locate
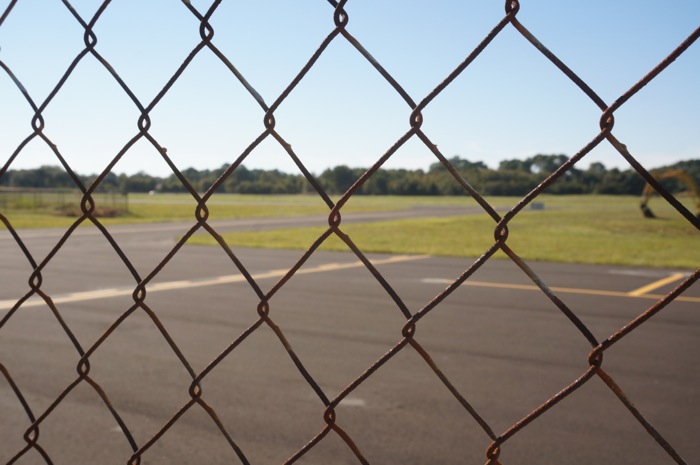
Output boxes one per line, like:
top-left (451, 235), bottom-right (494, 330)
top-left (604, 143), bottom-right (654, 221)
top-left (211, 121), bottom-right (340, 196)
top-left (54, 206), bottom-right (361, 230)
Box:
top-left (2, 194), bottom-right (700, 269)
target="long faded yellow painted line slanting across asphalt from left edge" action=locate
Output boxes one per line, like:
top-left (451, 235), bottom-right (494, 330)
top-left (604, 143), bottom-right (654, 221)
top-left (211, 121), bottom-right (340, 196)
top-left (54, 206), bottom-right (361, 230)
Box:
top-left (0, 255), bottom-right (428, 310)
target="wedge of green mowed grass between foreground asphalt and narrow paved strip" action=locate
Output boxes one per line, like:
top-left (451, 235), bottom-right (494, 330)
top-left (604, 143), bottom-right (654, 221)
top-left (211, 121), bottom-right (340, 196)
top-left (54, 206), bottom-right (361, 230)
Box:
top-left (190, 206), bottom-right (700, 269)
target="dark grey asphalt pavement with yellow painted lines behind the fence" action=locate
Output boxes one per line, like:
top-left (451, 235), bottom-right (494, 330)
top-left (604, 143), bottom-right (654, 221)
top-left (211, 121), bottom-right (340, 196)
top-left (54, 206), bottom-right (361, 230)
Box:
top-left (0, 215), bottom-right (700, 465)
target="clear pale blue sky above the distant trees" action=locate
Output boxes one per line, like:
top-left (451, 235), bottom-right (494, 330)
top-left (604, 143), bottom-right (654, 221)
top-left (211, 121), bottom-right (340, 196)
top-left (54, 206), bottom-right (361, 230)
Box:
top-left (0, 0), bottom-right (700, 175)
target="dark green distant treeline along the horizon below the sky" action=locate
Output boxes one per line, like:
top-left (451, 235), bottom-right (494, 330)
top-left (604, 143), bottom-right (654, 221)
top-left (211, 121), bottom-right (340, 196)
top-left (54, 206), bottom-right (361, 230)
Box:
top-left (0, 154), bottom-right (700, 196)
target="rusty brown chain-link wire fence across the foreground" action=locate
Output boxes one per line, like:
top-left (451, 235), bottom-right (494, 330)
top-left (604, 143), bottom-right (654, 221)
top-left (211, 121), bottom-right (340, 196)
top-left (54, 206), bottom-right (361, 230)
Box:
top-left (0, 0), bottom-right (700, 465)
